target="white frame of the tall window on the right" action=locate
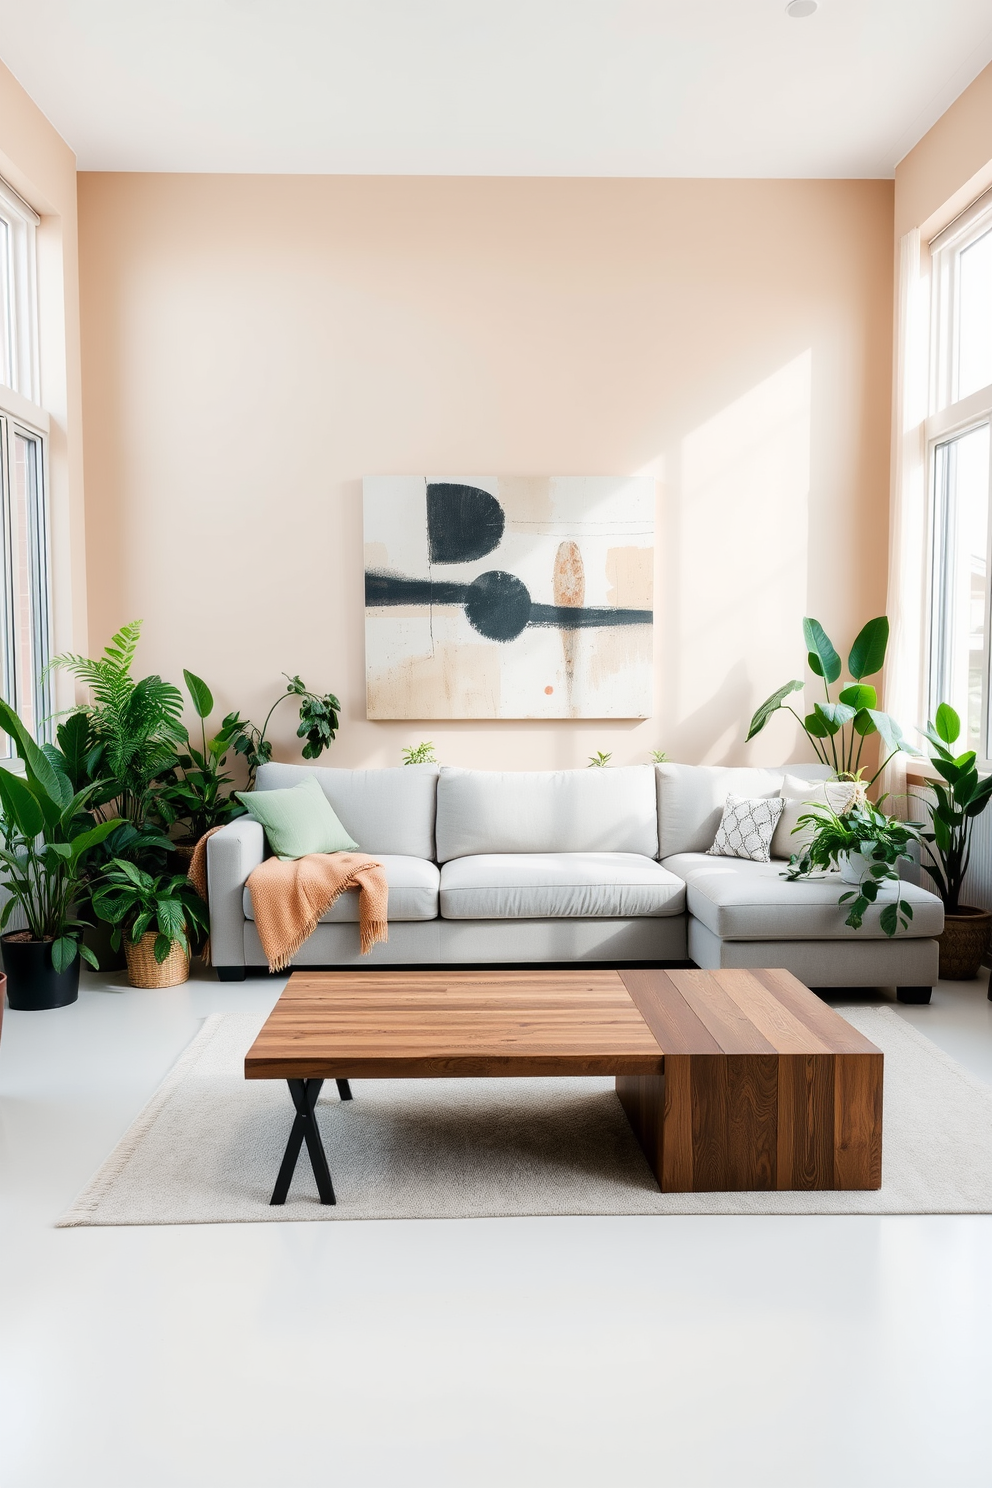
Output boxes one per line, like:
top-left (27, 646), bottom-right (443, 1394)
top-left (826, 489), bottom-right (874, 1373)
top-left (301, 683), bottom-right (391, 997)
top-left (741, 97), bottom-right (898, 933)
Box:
top-left (924, 192), bottom-right (992, 768)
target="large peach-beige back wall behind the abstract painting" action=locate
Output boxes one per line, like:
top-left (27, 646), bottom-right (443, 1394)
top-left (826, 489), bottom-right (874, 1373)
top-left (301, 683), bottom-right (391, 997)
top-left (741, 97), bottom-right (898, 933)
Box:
top-left (79, 174), bottom-right (892, 768)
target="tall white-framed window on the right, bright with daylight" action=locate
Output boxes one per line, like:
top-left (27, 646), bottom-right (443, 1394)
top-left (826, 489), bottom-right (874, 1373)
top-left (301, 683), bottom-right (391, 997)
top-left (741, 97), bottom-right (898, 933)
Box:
top-left (927, 188), bottom-right (992, 762)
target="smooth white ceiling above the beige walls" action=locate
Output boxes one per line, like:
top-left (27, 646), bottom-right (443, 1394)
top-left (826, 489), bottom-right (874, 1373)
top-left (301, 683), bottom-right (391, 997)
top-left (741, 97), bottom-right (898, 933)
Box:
top-left (0, 0), bottom-right (992, 177)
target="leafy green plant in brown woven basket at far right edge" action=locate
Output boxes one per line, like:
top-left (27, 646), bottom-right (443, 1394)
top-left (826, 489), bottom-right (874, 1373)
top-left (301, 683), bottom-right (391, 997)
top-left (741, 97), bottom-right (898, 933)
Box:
top-left (921, 702), bottom-right (992, 995)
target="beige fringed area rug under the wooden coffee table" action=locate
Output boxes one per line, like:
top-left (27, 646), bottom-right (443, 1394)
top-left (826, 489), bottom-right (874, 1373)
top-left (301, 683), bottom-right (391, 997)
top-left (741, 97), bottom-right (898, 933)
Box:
top-left (58, 1007), bottom-right (992, 1226)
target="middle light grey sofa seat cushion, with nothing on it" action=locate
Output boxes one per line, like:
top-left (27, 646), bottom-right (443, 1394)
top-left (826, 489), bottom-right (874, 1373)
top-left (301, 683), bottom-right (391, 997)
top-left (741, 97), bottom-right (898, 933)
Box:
top-left (440, 853), bottom-right (686, 920)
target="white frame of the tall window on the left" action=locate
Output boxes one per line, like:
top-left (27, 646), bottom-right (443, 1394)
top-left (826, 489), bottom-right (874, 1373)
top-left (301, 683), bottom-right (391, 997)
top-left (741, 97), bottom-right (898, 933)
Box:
top-left (0, 179), bottom-right (54, 759)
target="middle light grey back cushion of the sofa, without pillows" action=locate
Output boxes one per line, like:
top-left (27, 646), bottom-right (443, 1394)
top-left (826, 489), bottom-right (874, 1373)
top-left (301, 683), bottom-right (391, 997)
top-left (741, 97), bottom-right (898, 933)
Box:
top-left (437, 765), bottom-right (657, 863)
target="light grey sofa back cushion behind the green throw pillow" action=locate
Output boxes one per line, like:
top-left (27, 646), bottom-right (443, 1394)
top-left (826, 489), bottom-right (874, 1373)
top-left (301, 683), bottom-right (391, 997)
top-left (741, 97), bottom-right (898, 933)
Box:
top-left (256, 765), bottom-right (437, 859)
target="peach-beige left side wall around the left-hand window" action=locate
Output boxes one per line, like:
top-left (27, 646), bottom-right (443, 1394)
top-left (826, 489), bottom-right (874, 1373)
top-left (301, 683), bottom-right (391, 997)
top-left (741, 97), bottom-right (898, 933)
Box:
top-left (0, 64), bottom-right (86, 684)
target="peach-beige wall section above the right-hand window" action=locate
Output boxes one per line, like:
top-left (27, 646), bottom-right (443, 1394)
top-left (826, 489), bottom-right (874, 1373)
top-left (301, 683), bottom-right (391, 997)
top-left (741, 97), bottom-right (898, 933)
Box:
top-left (895, 65), bottom-right (992, 241)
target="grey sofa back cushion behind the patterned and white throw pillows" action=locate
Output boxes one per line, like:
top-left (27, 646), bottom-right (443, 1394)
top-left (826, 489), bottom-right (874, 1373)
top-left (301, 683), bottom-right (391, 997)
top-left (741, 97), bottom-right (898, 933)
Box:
top-left (654, 765), bottom-right (830, 862)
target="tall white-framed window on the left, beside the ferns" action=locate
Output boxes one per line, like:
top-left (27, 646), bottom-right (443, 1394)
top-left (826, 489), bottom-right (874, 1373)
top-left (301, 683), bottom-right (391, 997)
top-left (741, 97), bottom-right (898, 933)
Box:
top-left (0, 182), bottom-right (52, 757)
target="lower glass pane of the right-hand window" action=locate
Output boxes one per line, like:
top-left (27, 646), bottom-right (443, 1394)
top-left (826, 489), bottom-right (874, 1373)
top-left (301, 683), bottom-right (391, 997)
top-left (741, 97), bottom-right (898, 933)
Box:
top-left (931, 424), bottom-right (989, 759)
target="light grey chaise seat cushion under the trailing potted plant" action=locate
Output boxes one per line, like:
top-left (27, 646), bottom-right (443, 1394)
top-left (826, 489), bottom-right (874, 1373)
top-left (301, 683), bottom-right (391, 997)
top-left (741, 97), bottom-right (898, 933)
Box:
top-left (662, 853), bottom-right (944, 940)
